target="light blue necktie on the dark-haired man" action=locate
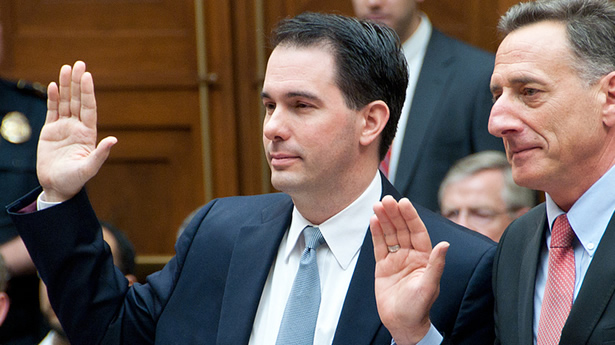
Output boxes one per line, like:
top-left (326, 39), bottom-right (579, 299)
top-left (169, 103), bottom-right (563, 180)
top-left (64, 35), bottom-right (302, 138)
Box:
top-left (276, 225), bottom-right (325, 345)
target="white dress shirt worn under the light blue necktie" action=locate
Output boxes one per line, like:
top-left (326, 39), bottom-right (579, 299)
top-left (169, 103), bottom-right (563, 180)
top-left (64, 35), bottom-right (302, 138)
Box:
top-left (249, 173), bottom-right (382, 345)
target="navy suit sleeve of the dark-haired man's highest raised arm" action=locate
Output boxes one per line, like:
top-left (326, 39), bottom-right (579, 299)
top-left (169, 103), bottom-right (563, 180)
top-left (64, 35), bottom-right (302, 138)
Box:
top-left (8, 188), bottom-right (213, 345)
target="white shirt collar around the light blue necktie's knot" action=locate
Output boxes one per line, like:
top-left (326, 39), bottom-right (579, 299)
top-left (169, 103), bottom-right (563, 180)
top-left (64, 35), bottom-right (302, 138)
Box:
top-left (284, 173), bottom-right (382, 269)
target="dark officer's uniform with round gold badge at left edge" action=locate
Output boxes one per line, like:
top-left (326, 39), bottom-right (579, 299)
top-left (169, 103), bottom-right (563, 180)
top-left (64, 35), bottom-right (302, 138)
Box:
top-left (0, 79), bottom-right (47, 344)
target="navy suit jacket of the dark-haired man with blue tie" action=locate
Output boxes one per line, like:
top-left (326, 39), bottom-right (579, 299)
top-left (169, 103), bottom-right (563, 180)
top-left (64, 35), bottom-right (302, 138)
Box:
top-left (9, 178), bottom-right (495, 345)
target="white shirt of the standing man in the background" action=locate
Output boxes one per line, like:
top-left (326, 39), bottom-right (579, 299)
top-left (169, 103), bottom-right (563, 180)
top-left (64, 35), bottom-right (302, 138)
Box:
top-left (388, 13), bottom-right (432, 183)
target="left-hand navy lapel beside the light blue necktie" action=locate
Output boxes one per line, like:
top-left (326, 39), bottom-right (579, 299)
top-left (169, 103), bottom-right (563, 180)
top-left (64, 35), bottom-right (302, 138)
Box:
top-left (217, 198), bottom-right (292, 345)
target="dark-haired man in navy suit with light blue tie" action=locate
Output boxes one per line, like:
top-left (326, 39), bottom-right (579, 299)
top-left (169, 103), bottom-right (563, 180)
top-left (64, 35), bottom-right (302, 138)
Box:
top-left (4, 13), bottom-right (495, 345)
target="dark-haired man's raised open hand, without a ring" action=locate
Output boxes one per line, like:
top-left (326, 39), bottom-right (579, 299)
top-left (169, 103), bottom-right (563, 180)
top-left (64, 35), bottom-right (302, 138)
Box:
top-left (36, 61), bottom-right (117, 202)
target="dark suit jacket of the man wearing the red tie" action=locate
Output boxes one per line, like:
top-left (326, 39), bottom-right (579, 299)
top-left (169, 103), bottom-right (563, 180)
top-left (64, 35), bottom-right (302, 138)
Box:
top-left (493, 203), bottom-right (615, 345)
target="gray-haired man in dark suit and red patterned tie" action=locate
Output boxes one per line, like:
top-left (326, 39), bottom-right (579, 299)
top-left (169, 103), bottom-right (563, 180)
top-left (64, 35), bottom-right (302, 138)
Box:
top-left (372, 0), bottom-right (615, 345)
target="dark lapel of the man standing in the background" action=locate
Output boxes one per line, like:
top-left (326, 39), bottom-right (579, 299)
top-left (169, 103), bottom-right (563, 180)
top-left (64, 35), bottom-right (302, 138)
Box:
top-left (395, 29), bottom-right (454, 191)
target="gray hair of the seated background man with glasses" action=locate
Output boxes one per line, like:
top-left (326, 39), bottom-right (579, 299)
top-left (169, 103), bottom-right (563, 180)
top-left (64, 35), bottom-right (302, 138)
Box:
top-left (438, 151), bottom-right (536, 212)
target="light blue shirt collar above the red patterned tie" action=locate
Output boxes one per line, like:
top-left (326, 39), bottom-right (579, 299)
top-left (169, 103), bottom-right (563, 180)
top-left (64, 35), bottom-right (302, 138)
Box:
top-left (545, 167), bottom-right (615, 256)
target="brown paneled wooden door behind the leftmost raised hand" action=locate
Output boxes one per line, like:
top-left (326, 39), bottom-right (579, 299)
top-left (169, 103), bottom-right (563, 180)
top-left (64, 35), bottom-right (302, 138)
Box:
top-left (0, 0), bottom-right (205, 274)
